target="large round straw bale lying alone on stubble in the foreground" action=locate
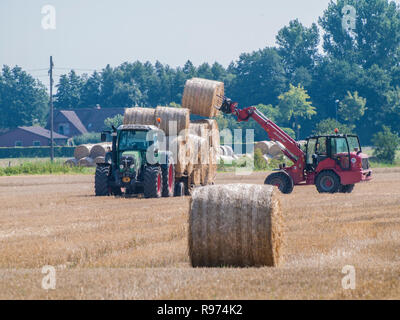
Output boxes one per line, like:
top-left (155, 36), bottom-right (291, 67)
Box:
top-left (189, 184), bottom-right (283, 267)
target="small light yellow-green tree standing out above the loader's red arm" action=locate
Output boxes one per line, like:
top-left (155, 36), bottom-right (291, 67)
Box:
top-left (279, 84), bottom-right (317, 139)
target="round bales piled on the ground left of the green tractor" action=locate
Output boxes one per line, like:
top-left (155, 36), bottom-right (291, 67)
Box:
top-left (65, 143), bottom-right (112, 167)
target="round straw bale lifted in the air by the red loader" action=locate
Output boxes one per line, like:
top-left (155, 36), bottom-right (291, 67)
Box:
top-left (182, 78), bottom-right (224, 118)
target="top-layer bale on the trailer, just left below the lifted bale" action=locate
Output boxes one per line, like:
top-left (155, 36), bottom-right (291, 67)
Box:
top-left (155, 107), bottom-right (190, 137)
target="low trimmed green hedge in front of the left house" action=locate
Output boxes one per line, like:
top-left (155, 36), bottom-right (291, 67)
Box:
top-left (0, 147), bottom-right (75, 159)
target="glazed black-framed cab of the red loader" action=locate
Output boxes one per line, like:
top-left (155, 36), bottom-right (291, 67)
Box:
top-left (306, 135), bottom-right (362, 172)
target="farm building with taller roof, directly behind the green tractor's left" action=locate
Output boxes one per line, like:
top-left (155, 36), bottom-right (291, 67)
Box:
top-left (46, 107), bottom-right (125, 137)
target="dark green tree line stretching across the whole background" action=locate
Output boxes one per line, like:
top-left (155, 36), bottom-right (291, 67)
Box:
top-left (0, 0), bottom-right (400, 144)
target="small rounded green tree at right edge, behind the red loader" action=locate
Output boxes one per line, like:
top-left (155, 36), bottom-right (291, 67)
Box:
top-left (372, 126), bottom-right (400, 163)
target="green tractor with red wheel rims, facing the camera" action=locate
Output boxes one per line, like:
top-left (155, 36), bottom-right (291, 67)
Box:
top-left (95, 125), bottom-right (185, 198)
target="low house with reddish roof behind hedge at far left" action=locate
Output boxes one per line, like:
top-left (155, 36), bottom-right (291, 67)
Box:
top-left (0, 127), bottom-right (68, 147)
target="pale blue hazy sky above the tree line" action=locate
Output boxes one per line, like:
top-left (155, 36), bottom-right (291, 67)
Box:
top-left (0, 0), bottom-right (396, 87)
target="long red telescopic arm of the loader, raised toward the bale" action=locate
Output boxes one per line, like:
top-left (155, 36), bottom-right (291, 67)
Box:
top-left (220, 98), bottom-right (305, 172)
